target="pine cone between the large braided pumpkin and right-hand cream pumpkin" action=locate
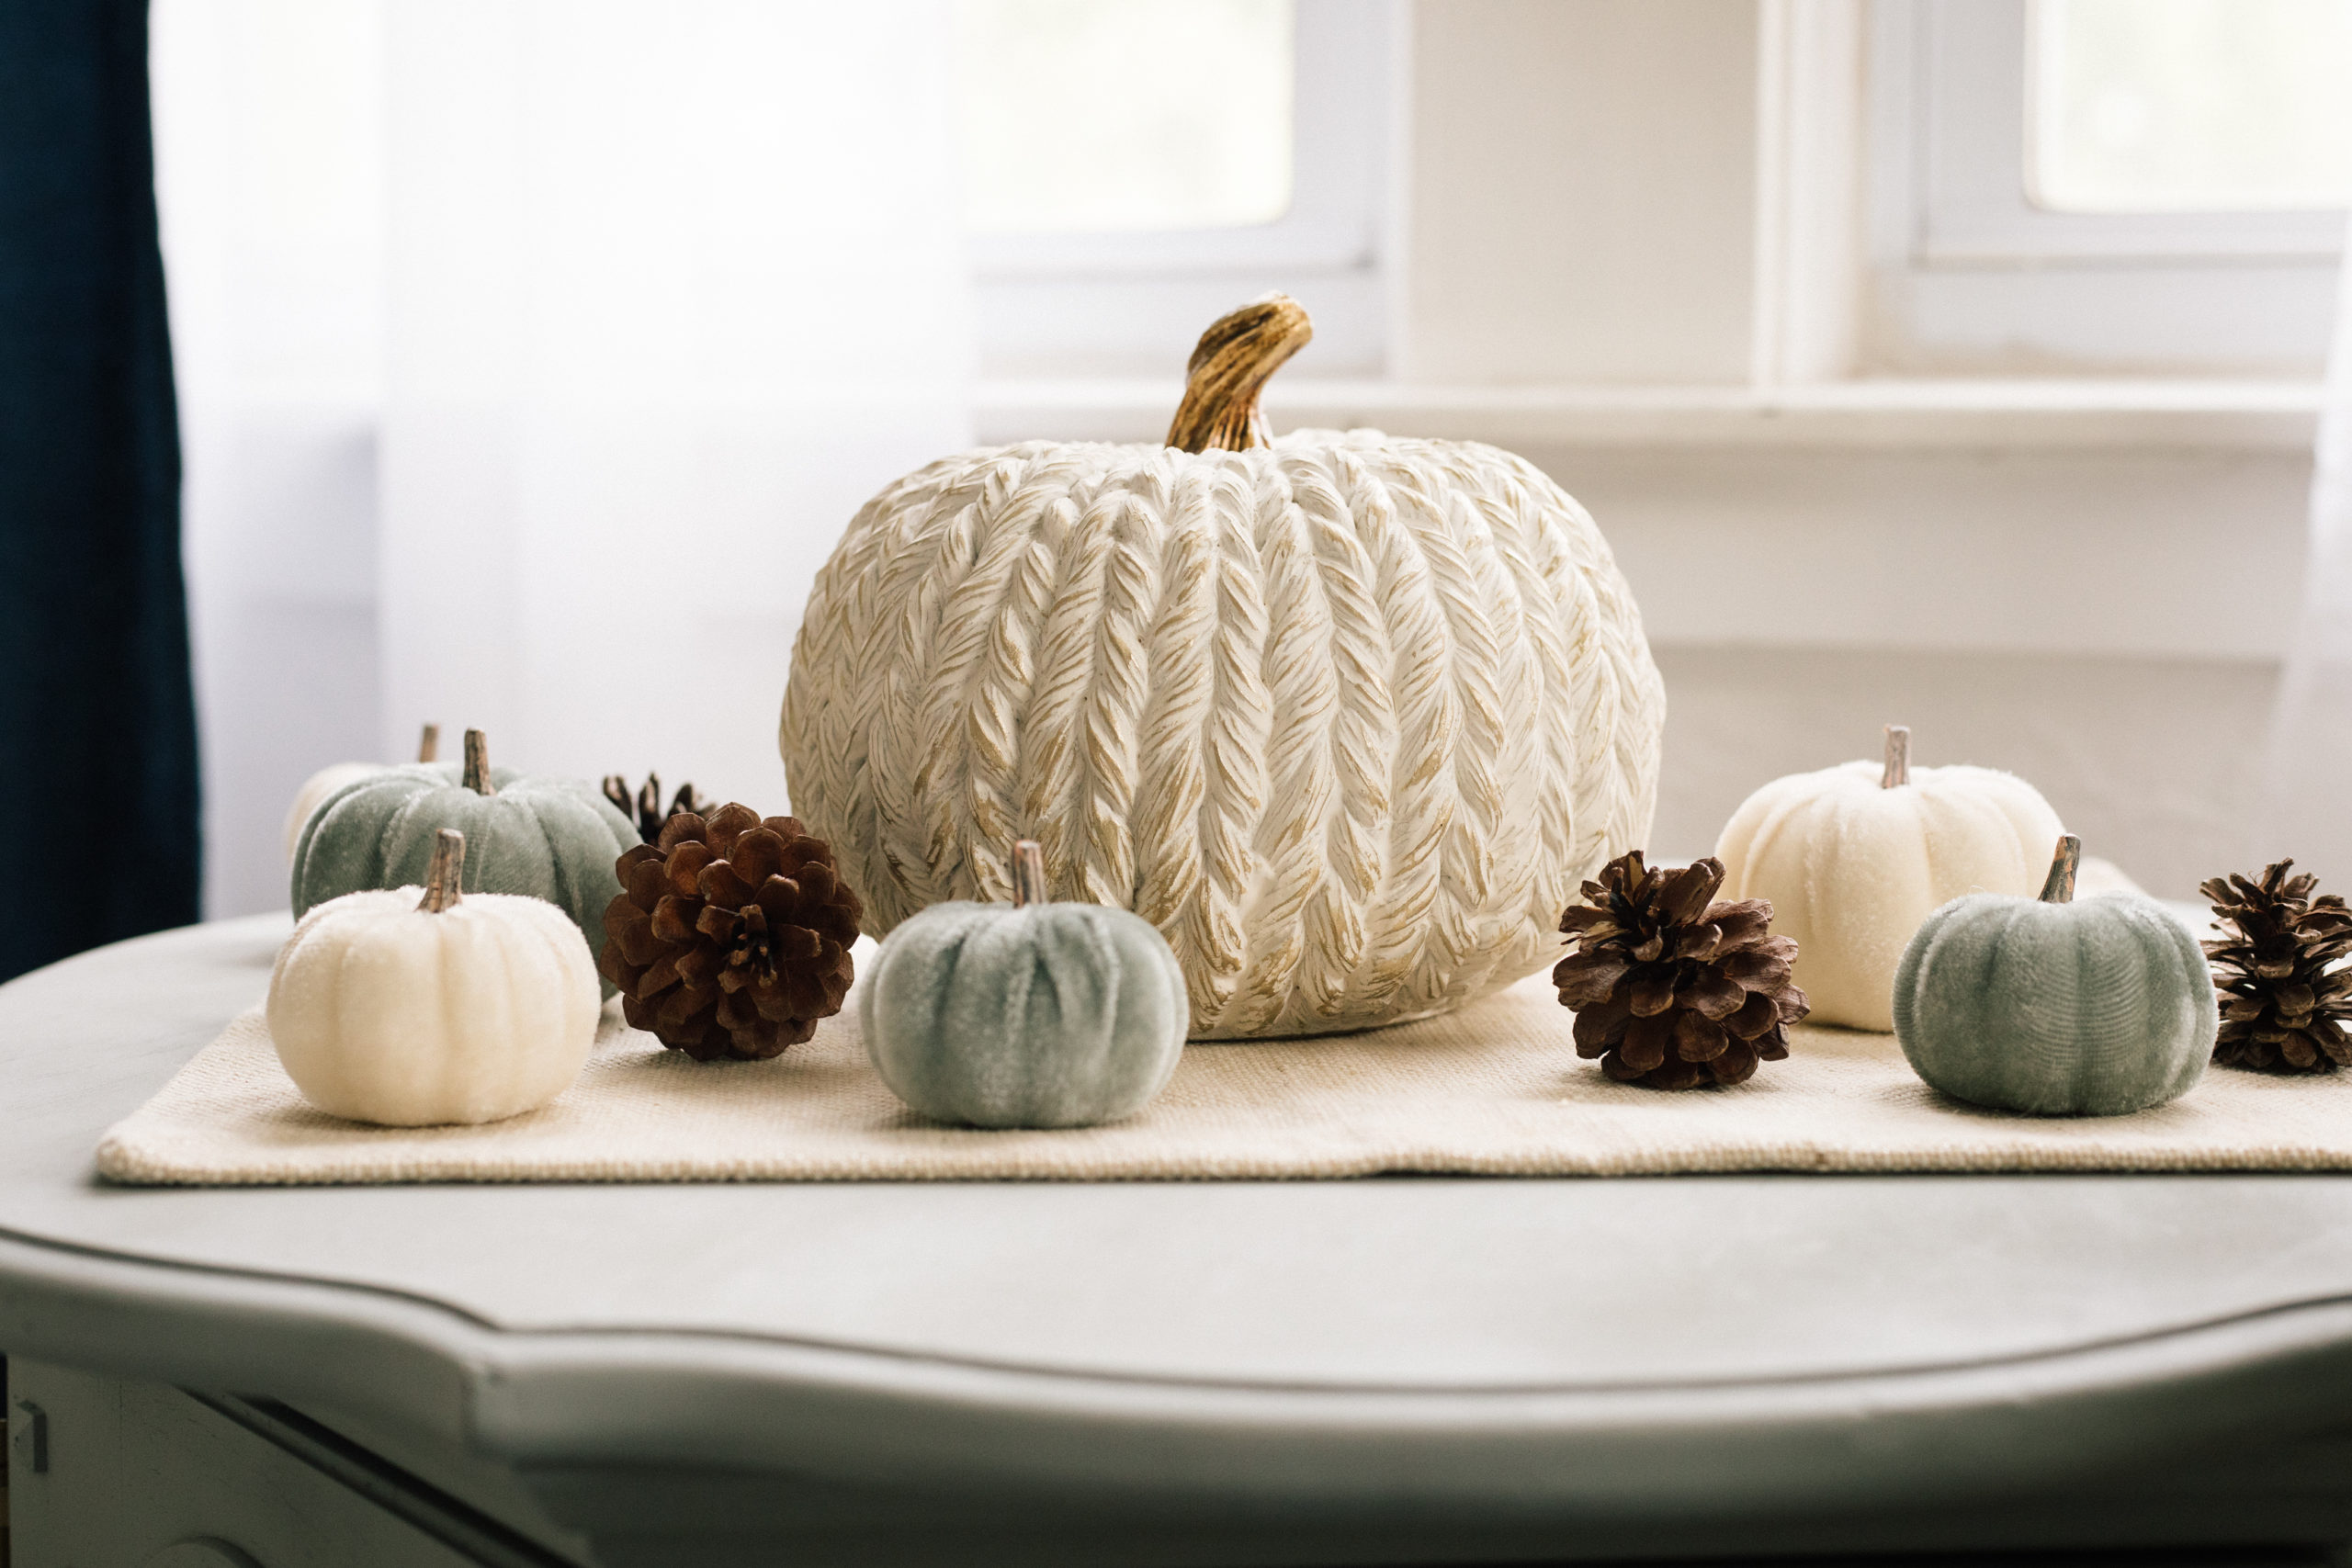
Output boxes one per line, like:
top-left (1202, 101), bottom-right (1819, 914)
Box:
top-left (1553, 849), bottom-right (1811, 1089)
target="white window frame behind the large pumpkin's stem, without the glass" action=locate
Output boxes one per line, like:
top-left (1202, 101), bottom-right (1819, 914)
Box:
top-left (971, 0), bottom-right (1404, 378)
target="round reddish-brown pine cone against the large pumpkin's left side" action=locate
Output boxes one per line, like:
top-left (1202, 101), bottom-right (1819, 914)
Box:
top-left (597, 804), bottom-right (861, 1063)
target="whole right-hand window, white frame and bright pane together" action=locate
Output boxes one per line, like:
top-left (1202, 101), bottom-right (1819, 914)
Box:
top-left (1865, 0), bottom-right (2352, 374)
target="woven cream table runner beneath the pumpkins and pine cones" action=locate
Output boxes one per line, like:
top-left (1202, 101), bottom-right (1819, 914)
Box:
top-left (99, 976), bottom-right (2352, 1182)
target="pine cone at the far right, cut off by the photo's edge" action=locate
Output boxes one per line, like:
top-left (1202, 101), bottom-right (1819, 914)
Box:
top-left (2197, 861), bottom-right (2352, 1072)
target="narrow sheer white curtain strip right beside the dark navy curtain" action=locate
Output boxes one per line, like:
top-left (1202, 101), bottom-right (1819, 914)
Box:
top-left (151, 0), bottom-right (386, 915)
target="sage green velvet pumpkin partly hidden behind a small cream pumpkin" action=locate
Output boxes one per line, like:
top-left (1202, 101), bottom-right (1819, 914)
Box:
top-left (291, 728), bottom-right (638, 991)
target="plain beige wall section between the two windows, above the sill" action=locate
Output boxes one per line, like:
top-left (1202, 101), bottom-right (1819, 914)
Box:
top-left (1395, 0), bottom-right (1757, 383)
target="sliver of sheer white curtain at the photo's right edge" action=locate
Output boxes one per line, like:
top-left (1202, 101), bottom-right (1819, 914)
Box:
top-left (2242, 216), bottom-right (2352, 896)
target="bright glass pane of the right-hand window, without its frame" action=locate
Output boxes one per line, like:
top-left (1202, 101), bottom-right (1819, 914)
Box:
top-left (2028, 0), bottom-right (2352, 211)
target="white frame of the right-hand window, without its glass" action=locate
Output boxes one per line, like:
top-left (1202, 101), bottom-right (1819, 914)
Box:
top-left (1865, 0), bottom-right (2345, 374)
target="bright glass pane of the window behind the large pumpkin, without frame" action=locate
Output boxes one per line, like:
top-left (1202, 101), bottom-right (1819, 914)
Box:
top-left (957, 0), bottom-right (1291, 232)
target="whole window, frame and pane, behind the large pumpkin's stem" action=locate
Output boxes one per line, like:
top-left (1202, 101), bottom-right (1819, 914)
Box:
top-left (957, 0), bottom-right (1399, 376)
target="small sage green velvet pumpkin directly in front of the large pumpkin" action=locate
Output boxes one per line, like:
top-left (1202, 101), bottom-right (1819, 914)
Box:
top-left (858, 840), bottom-right (1185, 1126)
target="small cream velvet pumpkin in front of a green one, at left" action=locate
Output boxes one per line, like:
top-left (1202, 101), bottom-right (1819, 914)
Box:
top-left (268, 828), bottom-right (600, 1126)
